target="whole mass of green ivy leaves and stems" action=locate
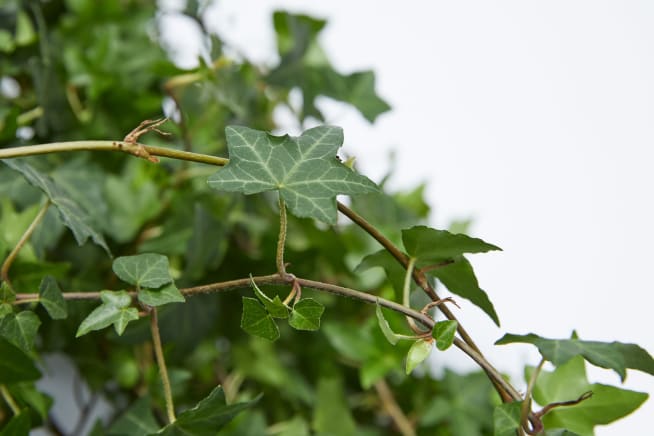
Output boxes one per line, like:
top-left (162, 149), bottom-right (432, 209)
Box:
top-left (0, 0), bottom-right (654, 436)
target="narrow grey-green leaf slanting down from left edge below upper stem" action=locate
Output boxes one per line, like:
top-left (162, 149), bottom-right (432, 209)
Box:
top-left (2, 159), bottom-right (111, 254)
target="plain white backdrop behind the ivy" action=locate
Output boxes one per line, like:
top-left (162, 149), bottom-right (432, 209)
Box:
top-left (162, 0), bottom-right (654, 435)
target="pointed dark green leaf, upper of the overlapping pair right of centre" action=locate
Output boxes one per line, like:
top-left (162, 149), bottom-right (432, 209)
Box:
top-left (402, 226), bottom-right (501, 267)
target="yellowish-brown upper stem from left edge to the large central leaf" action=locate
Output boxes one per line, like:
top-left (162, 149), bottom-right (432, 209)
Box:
top-left (0, 141), bottom-right (229, 166)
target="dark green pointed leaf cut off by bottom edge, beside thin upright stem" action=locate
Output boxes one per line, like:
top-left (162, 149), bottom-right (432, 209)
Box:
top-left (157, 386), bottom-right (261, 436)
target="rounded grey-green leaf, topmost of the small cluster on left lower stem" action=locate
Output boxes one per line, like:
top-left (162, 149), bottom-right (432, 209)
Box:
top-left (112, 253), bottom-right (173, 288)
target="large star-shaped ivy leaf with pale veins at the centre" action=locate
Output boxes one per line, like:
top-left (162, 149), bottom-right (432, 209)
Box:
top-left (208, 126), bottom-right (377, 224)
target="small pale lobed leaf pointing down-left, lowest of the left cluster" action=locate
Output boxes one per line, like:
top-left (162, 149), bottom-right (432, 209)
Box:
top-left (75, 291), bottom-right (139, 338)
